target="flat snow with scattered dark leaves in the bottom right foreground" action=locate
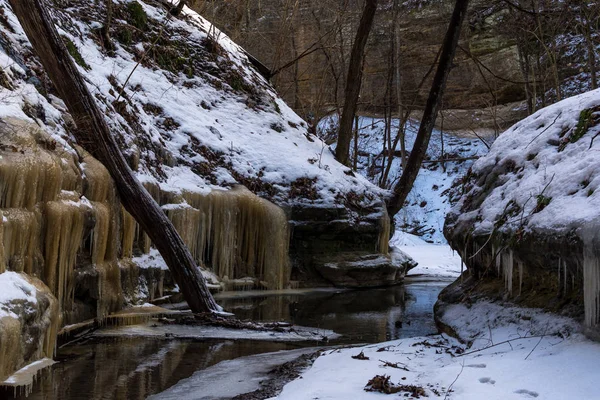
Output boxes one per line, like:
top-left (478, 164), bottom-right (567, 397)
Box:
top-left (276, 303), bottom-right (600, 400)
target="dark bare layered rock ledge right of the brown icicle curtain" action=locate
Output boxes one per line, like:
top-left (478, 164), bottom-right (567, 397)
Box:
top-left (290, 204), bottom-right (416, 288)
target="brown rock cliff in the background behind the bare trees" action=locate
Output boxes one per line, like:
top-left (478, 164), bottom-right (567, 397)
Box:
top-left (195, 0), bottom-right (525, 130)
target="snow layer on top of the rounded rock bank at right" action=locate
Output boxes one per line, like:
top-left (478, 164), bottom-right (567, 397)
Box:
top-left (451, 90), bottom-right (600, 234)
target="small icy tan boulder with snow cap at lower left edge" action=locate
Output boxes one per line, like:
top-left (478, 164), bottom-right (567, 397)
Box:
top-left (0, 272), bottom-right (59, 382)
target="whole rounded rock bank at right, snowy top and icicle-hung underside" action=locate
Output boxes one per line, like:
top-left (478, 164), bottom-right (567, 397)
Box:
top-left (444, 90), bottom-right (600, 336)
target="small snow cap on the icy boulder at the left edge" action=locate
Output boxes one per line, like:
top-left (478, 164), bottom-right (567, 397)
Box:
top-left (0, 271), bottom-right (37, 318)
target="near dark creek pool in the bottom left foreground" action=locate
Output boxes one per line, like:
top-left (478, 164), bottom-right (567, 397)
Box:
top-left (0, 338), bottom-right (297, 400)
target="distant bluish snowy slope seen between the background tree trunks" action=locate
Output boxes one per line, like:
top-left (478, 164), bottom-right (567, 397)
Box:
top-left (319, 117), bottom-right (493, 243)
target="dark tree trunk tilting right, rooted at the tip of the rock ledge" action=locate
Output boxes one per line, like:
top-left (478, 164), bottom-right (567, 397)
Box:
top-left (388, 0), bottom-right (469, 216)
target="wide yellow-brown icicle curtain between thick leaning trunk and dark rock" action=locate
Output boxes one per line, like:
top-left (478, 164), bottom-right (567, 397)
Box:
top-left (156, 187), bottom-right (292, 289)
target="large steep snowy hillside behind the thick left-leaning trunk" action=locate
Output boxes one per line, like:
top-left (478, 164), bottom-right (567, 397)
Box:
top-left (0, 0), bottom-right (381, 204)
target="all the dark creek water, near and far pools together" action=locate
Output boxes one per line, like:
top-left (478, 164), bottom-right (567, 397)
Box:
top-left (8, 282), bottom-right (448, 400)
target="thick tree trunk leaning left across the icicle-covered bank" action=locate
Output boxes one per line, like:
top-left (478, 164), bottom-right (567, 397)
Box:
top-left (10, 0), bottom-right (219, 313)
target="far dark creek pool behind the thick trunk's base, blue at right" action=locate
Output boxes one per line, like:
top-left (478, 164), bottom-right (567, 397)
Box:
top-left (218, 282), bottom-right (445, 343)
